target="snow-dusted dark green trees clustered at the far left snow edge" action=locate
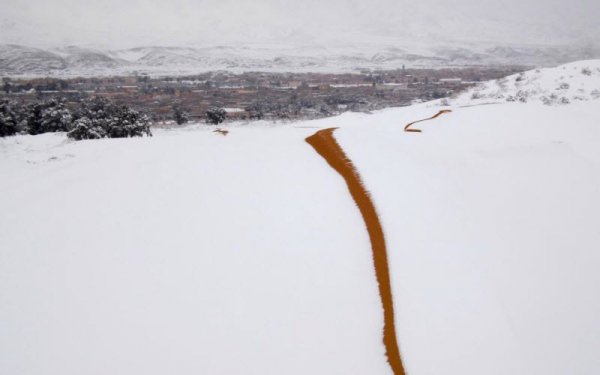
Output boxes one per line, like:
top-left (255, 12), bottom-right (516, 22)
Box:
top-left (0, 97), bottom-right (152, 140)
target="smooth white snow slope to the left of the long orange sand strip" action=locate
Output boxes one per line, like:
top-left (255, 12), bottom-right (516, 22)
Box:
top-left (0, 127), bottom-right (389, 375)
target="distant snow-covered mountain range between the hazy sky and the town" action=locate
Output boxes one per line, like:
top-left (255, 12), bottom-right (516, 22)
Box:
top-left (0, 45), bottom-right (600, 77)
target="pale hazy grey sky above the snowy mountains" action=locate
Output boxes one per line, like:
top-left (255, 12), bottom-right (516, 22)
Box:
top-left (0, 0), bottom-right (600, 48)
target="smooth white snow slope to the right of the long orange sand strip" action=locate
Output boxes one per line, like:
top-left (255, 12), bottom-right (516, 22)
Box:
top-left (338, 101), bottom-right (600, 375)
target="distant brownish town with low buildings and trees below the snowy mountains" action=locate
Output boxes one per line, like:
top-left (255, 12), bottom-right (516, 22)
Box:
top-left (0, 66), bottom-right (527, 124)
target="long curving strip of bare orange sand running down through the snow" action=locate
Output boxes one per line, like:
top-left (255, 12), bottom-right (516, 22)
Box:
top-left (306, 128), bottom-right (405, 375)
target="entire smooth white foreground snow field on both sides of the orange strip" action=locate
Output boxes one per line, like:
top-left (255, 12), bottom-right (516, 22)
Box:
top-left (0, 62), bottom-right (600, 375)
